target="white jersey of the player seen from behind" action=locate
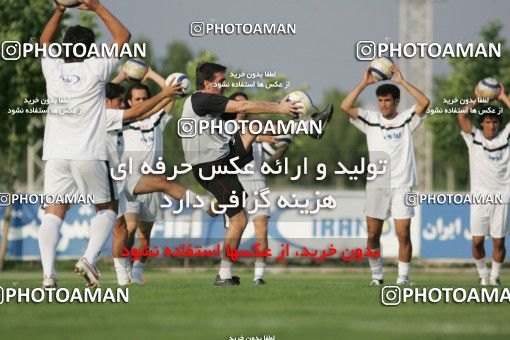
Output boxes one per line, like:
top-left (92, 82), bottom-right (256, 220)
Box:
top-left (42, 52), bottom-right (119, 160)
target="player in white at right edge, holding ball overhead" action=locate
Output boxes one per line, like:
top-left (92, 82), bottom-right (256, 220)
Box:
top-left (457, 85), bottom-right (510, 286)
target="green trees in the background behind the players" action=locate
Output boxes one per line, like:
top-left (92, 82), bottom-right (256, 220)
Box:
top-left (0, 0), bottom-right (510, 197)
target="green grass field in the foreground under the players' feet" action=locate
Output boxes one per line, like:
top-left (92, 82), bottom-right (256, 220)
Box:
top-left (0, 269), bottom-right (510, 340)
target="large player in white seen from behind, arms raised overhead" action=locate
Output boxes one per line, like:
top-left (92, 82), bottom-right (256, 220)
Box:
top-left (38, 0), bottom-right (131, 287)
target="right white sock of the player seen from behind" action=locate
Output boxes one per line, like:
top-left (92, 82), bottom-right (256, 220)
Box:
top-left (83, 209), bottom-right (117, 266)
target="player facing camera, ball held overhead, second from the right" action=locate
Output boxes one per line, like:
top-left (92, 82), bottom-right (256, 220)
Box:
top-left (341, 65), bottom-right (429, 286)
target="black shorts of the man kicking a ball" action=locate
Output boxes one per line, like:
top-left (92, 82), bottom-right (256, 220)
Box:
top-left (193, 133), bottom-right (253, 217)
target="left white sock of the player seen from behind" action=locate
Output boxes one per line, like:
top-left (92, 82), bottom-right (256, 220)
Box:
top-left (37, 214), bottom-right (63, 277)
